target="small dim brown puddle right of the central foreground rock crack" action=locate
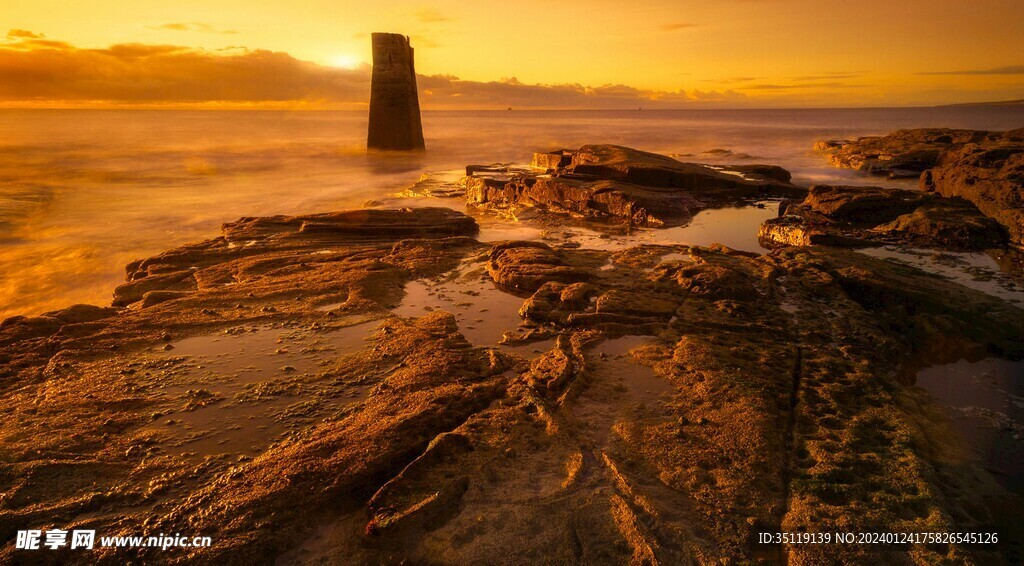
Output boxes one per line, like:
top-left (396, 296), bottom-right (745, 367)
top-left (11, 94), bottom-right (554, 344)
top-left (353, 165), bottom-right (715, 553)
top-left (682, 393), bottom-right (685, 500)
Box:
top-left (572, 336), bottom-right (676, 448)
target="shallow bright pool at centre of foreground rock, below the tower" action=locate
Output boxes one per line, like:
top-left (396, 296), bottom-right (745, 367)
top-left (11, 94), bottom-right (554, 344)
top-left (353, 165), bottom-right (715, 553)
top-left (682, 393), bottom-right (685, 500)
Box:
top-left (391, 259), bottom-right (524, 346)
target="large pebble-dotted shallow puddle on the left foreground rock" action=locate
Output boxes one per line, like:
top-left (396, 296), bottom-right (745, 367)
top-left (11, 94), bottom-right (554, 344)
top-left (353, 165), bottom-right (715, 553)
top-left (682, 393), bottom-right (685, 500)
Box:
top-left (151, 320), bottom-right (380, 456)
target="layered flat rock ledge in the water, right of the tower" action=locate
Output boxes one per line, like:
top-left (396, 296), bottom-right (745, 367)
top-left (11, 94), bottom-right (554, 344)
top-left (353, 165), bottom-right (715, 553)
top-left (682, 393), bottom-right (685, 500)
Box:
top-left (461, 145), bottom-right (804, 226)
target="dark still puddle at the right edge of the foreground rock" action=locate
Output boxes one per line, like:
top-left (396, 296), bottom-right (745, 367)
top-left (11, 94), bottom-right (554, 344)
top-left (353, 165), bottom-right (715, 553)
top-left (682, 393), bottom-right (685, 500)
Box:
top-left (915, 358), bottom-right (1024, 493)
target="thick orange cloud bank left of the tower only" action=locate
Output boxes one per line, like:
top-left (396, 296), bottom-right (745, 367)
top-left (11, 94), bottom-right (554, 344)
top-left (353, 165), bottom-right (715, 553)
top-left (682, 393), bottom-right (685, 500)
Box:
top-left (0, 34), bottom-right (370, 102)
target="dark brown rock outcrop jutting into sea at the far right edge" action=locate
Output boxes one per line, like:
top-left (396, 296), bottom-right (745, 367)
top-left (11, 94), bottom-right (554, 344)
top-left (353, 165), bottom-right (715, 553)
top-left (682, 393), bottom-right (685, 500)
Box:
top-left (815, 129), bottom-right (1024, 247)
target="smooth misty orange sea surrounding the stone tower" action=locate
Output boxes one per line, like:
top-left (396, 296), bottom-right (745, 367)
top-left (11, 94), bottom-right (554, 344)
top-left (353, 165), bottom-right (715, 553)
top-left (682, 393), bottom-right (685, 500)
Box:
top-left (0, 107), bottom-right (1024, 318)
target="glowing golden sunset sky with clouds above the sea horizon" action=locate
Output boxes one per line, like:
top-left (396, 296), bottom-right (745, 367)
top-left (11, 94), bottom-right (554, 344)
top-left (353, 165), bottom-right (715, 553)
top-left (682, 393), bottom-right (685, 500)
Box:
top-left (0, 0), bottom-right (1024, 108)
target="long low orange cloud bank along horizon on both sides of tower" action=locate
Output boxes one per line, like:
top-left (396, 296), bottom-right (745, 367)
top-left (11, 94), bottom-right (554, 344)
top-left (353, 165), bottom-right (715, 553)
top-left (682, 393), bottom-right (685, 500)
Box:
top-left (0, 30), bottom-right (743, 108)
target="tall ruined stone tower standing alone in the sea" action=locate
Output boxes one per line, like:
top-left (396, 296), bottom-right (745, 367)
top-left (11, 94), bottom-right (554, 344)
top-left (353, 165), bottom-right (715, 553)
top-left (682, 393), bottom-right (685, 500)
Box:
top-left (367, 34), bottom-right (424, 149)
